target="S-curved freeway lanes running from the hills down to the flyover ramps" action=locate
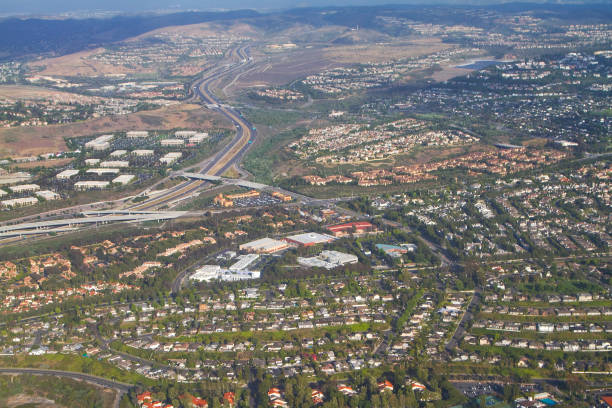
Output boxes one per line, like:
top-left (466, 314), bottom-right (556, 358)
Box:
top-left (129, 47), bottom-right (257, 210)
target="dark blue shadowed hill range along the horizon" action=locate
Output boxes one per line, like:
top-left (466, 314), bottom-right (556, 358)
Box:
top-left (0, 3), bottom-right (612, 61)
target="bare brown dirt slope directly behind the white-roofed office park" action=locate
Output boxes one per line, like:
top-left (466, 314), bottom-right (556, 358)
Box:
top-left (0, 104), bottom-right (231, 157)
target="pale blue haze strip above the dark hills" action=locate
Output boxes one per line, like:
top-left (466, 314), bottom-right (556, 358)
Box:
top-left (0, 0), bottom-right (609, 16)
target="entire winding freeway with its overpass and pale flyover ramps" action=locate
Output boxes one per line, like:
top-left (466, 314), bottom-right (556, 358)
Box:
top-left (0, 46), bottom-right (354, 241)
